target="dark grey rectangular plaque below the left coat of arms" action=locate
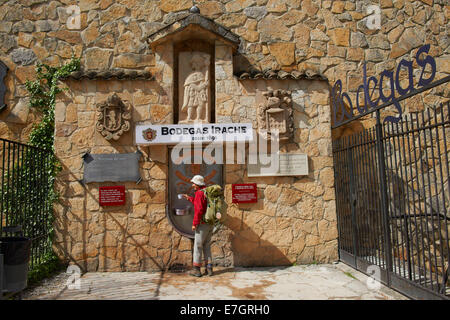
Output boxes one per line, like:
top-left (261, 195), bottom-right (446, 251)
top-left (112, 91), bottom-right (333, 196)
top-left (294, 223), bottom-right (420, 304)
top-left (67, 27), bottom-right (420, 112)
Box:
top-left (83, 152), bottom-right (141, 183)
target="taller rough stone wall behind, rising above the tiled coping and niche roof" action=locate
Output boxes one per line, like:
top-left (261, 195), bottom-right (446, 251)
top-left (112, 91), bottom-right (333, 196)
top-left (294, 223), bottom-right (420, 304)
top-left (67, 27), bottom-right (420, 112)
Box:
top-left (0, 0), bottom-right (450, 141)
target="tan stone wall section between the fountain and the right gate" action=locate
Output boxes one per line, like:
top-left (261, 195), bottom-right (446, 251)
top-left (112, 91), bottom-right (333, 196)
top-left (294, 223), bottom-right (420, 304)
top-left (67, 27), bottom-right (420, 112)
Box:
top-left (220, 80), bottom-right (337, 266)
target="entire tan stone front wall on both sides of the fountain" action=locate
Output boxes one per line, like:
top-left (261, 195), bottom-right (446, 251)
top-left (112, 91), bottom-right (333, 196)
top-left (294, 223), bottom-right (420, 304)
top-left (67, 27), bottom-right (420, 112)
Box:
top-left (51, 63), bottom-right (337, 271)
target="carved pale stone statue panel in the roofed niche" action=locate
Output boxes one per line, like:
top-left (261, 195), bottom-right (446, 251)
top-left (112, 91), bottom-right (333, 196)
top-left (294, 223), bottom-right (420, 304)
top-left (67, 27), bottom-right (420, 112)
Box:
top-left (179, 52), bottom-right (210, 123)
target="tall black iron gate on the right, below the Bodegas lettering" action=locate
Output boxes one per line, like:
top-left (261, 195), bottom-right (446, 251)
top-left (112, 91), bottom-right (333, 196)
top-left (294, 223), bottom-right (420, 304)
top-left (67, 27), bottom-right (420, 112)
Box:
top-left (333, 102), bottom-right (450, 299)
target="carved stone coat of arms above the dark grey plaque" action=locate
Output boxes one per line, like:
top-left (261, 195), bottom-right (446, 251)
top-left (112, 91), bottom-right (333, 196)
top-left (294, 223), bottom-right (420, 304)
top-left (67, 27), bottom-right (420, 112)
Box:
top-left (96, 93), bottom-right (131, 140)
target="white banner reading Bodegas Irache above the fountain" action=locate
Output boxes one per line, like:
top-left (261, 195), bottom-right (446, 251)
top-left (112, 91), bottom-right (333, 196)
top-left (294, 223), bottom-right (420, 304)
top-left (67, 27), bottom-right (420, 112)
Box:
top-left (135, 123), bottom-right (253, 145)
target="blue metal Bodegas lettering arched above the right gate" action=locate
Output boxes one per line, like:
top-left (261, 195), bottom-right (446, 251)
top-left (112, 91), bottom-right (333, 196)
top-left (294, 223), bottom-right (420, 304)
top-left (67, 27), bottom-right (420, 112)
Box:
top-left (331, 44), bottom-right (444, 128)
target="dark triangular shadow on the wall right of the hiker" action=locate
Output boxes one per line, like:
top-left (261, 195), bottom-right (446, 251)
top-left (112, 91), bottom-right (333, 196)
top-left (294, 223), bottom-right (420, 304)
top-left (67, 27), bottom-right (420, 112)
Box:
top-left (225, 216), bottom-right (292, 267)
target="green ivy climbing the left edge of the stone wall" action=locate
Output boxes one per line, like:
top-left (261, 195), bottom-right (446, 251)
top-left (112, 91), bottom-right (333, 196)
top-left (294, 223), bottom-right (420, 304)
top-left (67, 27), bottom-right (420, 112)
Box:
top-left (19, 57), bottom-right (80, 281)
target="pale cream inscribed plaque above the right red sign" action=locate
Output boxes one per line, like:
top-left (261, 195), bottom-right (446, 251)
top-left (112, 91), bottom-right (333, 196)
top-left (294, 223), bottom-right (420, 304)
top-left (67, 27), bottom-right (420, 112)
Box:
top-left (247, 153), bottom-right (309, 177)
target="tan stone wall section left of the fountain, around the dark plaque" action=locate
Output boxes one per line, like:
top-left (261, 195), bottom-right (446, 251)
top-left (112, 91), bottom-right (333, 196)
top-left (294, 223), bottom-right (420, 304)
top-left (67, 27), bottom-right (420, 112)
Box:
top-left (54, 80), bottom-right (174, 271)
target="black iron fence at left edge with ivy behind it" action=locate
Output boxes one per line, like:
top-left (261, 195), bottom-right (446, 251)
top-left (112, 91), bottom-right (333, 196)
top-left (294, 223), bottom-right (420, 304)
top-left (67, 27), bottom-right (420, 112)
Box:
top-left (0, 138), bottom-right (53, 269)
